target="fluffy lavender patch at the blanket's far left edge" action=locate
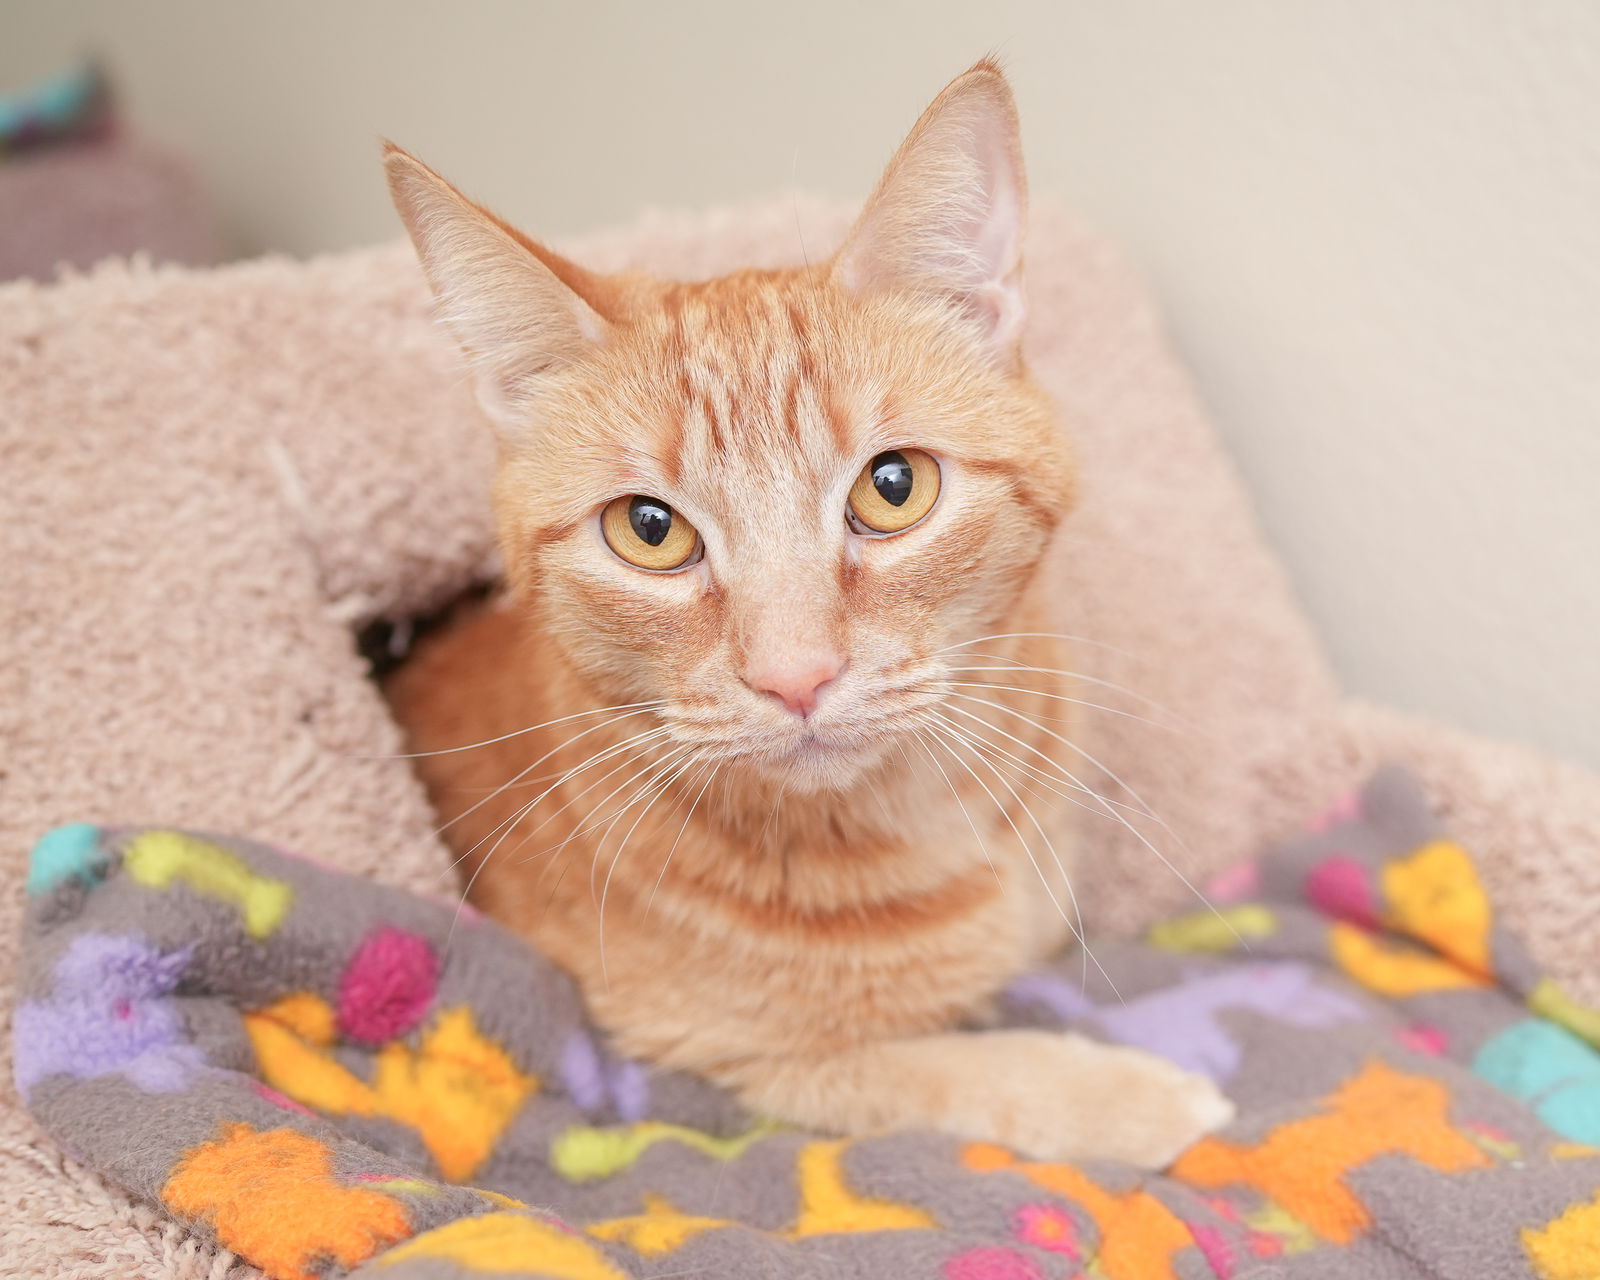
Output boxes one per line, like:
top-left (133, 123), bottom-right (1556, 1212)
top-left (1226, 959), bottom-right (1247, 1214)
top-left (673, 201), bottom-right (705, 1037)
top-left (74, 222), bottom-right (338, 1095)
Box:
top-left (13, 933), bottom-right (206, 1099)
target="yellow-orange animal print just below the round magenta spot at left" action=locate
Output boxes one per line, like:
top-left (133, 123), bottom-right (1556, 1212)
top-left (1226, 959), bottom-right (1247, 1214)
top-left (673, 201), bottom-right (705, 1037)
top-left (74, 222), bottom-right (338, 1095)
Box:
top-left (245, 992), bottom-right (539, 1182)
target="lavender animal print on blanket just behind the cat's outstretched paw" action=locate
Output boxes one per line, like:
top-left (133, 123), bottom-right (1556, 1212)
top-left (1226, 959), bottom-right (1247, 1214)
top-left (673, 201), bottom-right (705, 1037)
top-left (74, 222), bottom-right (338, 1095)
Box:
top-left (1006, 962), bottom-right (1365, 1083)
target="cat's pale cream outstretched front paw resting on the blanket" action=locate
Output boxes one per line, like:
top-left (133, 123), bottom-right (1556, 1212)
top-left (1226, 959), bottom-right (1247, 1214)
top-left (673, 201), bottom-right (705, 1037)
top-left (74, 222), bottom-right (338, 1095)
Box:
top-left (963, 1032), bottom-right (1235, 1170)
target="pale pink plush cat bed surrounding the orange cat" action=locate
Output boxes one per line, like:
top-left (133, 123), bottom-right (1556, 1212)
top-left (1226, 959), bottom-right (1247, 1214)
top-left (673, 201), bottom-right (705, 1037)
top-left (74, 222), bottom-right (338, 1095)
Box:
top-left (9, 200), bottom-right (1600, 1277)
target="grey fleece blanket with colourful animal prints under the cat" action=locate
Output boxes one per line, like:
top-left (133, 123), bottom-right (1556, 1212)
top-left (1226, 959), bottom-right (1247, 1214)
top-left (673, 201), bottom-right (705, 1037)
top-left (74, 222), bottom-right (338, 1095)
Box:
top-left (14, 771), bottom-right (1600, 1280)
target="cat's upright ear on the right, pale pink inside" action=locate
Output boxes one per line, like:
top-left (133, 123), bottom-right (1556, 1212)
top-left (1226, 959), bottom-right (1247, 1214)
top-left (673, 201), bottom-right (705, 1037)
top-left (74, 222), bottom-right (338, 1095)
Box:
top-left (834, 59), bottom-right (1027, 368)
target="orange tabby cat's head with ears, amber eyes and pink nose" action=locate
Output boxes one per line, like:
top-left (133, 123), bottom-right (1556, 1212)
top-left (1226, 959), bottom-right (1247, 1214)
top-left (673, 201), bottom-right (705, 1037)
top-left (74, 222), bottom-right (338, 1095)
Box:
top-left (387, 62), bottom-right (1072, 790)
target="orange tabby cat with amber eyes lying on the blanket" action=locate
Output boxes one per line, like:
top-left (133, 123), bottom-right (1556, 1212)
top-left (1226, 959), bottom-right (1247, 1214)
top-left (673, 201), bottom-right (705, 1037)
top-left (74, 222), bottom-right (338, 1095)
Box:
top-left (386, 61), bottom-right (1230, 1165)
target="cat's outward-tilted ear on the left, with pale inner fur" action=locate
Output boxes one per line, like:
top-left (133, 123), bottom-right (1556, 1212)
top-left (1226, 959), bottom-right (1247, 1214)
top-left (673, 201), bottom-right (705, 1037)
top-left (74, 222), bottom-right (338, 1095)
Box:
top-left (384, 142), bottom-right (608, 432)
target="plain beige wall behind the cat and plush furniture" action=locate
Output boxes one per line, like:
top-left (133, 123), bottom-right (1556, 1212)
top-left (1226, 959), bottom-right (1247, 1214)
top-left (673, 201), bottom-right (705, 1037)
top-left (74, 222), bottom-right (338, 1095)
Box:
top-left (0, 0), bottom-right (1600, 765)
